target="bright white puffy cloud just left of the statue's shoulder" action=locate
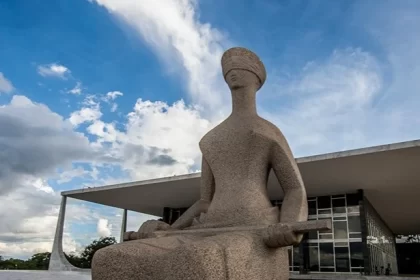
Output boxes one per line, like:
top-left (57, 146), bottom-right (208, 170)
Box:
top-left (82, 96), bottom-right (211, 180)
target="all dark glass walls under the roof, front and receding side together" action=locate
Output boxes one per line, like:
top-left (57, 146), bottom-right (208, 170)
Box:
top-left (163, 192), bottom-right (398, 274)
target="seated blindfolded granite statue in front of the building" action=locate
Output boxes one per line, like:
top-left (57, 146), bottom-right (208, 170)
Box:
top-left (92, 48), bottom-right (308, 280)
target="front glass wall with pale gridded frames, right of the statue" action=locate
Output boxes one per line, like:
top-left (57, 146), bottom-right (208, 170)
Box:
top-left (273, 193), bottom-right (364, 273)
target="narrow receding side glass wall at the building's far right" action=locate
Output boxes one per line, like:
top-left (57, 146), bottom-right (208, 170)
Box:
top-left (364, 198), bottom-right (398, 274)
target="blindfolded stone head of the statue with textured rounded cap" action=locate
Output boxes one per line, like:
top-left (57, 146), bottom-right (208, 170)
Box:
top-left (222, 47), bottom-right (267, 90)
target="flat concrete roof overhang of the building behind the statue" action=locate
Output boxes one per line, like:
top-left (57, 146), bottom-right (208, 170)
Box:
top-left (62, 140), bottom-right (420, 234)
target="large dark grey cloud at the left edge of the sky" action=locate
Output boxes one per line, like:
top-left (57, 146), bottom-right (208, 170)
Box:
top-left (0, 95), bottom-right (99, 194)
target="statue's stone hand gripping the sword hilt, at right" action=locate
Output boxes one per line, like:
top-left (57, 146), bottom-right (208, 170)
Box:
top-left (263, 224), bottom-right (303, 248)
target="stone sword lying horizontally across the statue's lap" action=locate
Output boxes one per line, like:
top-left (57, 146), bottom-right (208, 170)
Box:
top-left (151, 219), bottom-right (332, 248)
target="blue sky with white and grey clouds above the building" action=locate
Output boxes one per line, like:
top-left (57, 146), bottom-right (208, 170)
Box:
top-left (0, 0), bottom-right (420, 258)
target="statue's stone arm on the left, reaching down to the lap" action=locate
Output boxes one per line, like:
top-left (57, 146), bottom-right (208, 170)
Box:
top-left (171, 156), bottom-right (215, 229)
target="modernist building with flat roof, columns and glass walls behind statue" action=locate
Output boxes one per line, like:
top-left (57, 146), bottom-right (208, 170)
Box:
top-left (51, 140), bottom-right (420, 274)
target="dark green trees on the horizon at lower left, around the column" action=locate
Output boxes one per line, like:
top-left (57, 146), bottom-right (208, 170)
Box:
top-left (0, 237), bottom-right (117, 270)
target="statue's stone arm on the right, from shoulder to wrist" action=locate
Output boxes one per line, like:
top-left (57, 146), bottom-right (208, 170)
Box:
top-left (271, 138), bottom-right (308, 223)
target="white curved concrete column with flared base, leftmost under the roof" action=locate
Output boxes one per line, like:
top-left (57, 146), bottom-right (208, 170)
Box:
top-left (48, 196), bottom-right (83, 271)
